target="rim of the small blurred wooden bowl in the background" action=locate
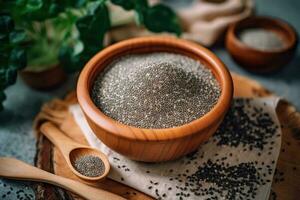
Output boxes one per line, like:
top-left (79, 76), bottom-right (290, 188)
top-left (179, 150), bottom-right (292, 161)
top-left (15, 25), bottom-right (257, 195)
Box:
top-left (227, 16), bottom-right (298, 55)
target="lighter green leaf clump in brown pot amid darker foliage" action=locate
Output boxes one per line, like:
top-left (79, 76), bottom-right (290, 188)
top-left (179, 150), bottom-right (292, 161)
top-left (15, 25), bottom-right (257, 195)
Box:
top-left (19, 14), bottom-right (72, 89)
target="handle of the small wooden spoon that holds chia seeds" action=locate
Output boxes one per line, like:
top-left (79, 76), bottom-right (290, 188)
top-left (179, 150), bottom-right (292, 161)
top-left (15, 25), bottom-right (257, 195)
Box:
top-left (40, 122), bottom-right (84, 155)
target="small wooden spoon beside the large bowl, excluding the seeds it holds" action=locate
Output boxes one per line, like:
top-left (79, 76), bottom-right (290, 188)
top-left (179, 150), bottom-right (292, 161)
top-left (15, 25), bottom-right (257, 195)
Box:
top-left (40, 122), bottom-right (110, 181)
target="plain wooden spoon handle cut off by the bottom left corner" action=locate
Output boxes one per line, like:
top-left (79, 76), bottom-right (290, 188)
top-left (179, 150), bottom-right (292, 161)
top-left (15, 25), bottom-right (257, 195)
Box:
top-left (0, 158), bottom-right (125, 200)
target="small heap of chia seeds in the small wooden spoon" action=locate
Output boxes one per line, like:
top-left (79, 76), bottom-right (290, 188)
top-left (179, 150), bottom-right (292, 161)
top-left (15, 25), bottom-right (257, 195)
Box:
top-left (74, 155), bottom-right (105, 177)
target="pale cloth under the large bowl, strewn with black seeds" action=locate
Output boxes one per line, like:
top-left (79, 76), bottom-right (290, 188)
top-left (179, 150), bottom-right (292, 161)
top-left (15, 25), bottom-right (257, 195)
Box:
top-left (70, 97), bottom-right (281, 199)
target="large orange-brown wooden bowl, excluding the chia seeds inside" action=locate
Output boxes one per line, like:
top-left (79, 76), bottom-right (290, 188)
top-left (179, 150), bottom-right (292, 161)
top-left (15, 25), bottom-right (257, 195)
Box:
top-left (77, 37), bottom-right (233, 162)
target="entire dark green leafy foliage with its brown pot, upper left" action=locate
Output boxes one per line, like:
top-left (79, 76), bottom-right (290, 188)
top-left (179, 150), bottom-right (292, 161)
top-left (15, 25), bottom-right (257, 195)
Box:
top-left (0, 0), bottom-right (181, 109)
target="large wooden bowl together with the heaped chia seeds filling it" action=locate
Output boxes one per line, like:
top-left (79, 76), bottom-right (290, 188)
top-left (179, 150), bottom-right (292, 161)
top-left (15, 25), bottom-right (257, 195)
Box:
top-left (77, 36), bottom-right (233, 162)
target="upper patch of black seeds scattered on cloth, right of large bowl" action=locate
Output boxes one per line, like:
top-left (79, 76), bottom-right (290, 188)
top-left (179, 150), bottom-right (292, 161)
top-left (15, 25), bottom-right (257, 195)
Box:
top-left (215, 99), bottom-right (277, 150)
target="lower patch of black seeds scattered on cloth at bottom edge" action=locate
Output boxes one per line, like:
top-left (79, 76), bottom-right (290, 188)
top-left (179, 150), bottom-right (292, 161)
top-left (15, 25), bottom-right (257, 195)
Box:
top-left (180, 160), bottom-right (264, 199)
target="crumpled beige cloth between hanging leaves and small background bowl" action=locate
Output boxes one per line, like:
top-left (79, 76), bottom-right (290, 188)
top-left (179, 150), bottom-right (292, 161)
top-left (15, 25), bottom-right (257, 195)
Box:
top-left (177, 0), bottom-right (254, 46)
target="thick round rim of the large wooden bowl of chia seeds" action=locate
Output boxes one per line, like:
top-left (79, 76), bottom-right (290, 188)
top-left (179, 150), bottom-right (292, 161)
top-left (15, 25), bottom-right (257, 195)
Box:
top-left (77, 36), bottom-right (233, 141)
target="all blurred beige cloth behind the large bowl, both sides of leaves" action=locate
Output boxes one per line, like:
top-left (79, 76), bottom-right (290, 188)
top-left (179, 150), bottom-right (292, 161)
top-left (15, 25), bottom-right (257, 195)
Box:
top-left (108, 0), bottom-right (254, 46)
